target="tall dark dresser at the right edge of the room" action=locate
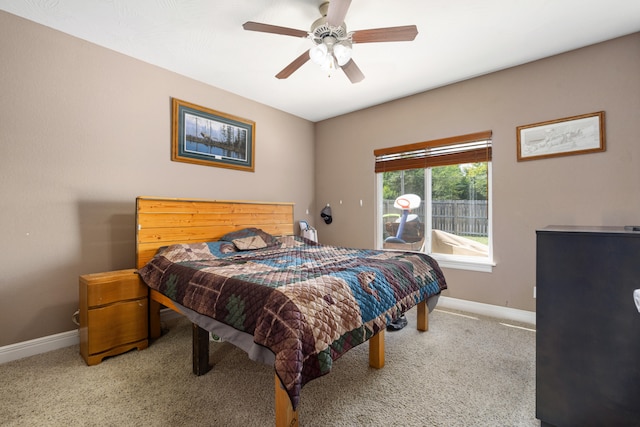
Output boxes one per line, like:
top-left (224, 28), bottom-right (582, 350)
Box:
top-left (536, 226), bottom-right (640, 427)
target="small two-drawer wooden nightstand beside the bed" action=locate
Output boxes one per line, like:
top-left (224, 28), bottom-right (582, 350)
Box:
top-left (79, 269), bottom-right (149, 365)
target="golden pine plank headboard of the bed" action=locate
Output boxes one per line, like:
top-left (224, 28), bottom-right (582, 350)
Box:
top-left (136, 196), bottom-right (294, 268)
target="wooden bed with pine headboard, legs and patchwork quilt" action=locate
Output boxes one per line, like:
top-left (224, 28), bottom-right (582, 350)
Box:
top-left (136, 197), bottom-right (446, 426)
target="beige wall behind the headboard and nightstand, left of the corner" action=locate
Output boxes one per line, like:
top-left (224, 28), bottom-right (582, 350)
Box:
top-left (0, 12), bottom-right (314, 346)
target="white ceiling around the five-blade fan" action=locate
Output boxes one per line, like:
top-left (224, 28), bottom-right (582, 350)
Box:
top-left (0, 0), bottom-right (640, 122)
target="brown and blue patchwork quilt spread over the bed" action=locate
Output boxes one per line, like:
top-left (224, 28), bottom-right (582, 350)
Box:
top-left (139, 236), bottom-right (447, 409)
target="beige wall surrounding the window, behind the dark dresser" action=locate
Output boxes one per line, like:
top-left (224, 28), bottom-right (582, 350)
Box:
top-left (316, 33), bottom-right (640, 311)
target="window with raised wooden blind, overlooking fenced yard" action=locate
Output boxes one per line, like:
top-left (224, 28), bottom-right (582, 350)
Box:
top-left (374, 131), bottom-right (493, 271)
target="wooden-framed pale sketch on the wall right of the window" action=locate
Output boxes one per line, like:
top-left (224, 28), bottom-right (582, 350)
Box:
top-left (516, 111), bottom-right (606, 162)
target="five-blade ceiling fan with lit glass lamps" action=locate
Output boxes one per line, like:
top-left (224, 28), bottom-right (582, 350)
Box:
top-left (242, 0), bottom-right (418, 83)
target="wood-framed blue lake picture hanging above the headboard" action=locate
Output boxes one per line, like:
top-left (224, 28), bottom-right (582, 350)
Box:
top-left (171, 98), bottom-right (256, 172)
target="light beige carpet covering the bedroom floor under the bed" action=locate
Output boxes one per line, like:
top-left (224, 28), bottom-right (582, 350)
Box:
top-left (0, 309), bottom-right (540, 427)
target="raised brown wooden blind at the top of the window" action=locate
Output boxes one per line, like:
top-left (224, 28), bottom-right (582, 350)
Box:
top-left (373, 131), bottom-right (493, 173)
